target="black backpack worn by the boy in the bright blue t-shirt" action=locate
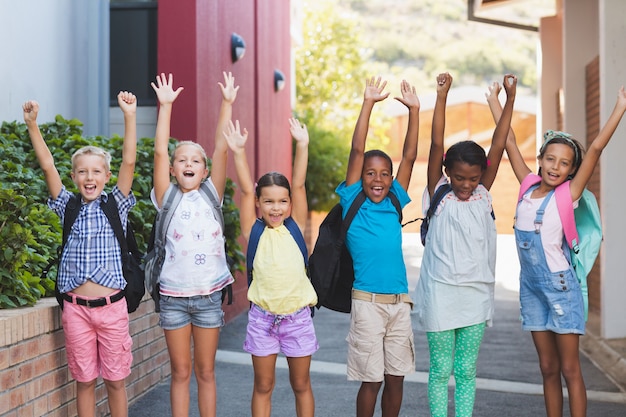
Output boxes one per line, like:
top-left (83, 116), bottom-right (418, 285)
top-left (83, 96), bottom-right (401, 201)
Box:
top-left (309, 191), bottom-right (402, 313)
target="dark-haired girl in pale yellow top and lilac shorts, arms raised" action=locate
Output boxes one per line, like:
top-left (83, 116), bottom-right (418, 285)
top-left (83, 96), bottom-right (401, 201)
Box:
top-left (224, 119), bottom-right (319, 417)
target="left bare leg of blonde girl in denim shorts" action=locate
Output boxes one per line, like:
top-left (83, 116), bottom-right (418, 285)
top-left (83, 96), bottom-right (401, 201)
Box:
top-left (164, 324), bottom-right (191, 417)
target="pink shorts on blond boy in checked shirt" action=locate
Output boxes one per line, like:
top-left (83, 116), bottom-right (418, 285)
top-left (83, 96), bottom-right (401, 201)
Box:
top-left (62, 292), bottom-right (133, 382)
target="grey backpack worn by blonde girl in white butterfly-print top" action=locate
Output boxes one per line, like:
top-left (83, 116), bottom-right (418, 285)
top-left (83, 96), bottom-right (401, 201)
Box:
top-left (145, 181), bottom-right (233, 312)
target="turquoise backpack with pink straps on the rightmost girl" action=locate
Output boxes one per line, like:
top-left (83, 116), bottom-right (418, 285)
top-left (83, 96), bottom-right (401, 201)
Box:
top-left (518, 174), bottom-right (602, 319)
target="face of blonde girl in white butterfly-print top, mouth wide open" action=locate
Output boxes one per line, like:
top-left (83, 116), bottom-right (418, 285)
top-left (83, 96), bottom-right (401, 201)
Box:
top-left (170, 145), bottom-right (209, 192)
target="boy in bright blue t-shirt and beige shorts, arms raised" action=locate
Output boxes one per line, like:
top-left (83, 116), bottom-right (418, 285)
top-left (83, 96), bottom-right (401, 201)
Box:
top-left (336, 77), bottom-right (420, 417)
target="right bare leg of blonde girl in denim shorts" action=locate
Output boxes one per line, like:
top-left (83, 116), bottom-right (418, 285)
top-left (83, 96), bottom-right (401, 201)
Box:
top-left (192, 326), bottom-right (220, 417)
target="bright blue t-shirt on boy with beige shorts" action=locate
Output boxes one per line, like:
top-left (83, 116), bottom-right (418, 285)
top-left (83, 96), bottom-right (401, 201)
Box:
top-left (335, 180), bottom-right (411, 294)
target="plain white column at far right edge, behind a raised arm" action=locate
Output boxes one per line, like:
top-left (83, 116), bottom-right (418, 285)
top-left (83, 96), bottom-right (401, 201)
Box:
top-left (599, 0), bottom-right (626, 339)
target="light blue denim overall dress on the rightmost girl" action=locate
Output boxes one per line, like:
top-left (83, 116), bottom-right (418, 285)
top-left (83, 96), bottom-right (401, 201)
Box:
top-left (515, 187), bottom-right (585, 334)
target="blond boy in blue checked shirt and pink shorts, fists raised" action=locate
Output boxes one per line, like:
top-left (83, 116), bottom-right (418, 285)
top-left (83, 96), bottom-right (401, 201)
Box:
top-left (22, 91), bottom-right (137, 417)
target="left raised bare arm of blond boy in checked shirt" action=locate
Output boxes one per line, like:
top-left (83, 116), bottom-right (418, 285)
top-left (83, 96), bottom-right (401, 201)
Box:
top-left (22, 100), bottom-right (63, 199)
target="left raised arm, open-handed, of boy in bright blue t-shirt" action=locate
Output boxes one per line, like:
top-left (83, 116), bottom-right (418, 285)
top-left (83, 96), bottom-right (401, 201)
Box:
top-left (346, 77), bottom-right (389, 185)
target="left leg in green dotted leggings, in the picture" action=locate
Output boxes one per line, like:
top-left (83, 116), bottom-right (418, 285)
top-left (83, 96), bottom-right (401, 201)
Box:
top-left (426, 330), bottom-right (454, 417)
